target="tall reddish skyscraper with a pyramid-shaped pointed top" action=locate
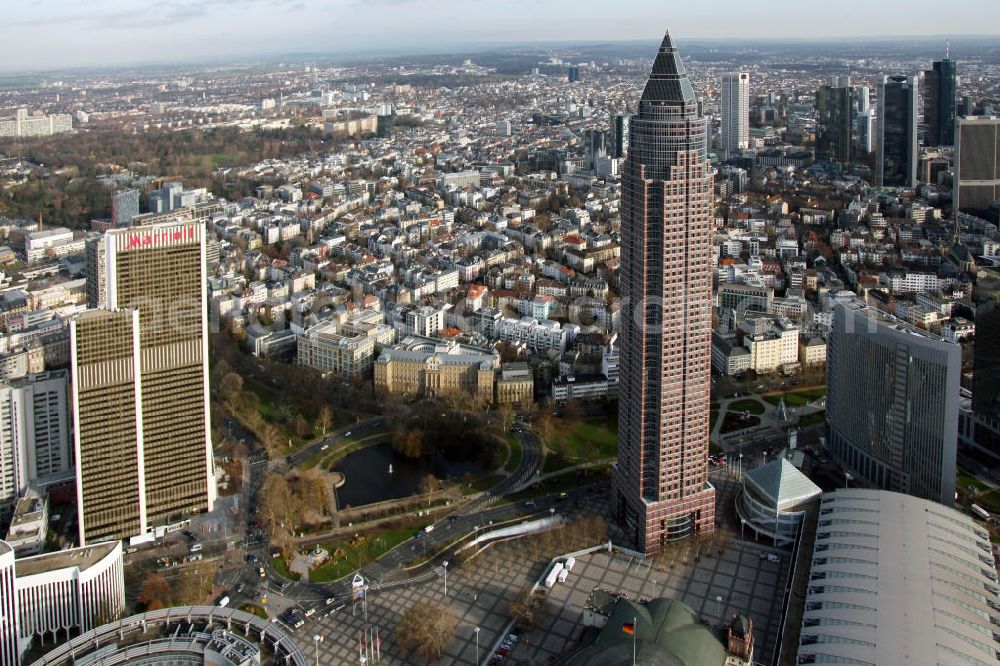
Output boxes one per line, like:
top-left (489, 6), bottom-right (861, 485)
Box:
top-left (612, 29), bottom-right (715, 553)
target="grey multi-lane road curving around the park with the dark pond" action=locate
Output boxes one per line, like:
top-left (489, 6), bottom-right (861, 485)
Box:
top-left (217, 417), bottom-right (548, 607)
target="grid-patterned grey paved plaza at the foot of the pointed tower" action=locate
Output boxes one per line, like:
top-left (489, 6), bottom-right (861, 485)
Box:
top-left (297, 528), bottom-right (789, 664)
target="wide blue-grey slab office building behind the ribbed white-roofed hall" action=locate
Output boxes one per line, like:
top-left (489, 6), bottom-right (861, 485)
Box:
top-left (827, 302), bottom-right (962, 505)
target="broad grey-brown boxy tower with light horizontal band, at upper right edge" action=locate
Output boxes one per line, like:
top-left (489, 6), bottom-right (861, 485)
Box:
top-left (954, 116), bottom-right (1000, 216)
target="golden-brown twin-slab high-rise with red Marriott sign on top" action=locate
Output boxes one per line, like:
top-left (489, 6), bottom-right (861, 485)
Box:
top-left (70, 222), bottom-right (215, 543)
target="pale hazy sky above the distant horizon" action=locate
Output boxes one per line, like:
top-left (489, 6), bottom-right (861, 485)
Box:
top-left (0, 0), bottom-right (1000, 72)
